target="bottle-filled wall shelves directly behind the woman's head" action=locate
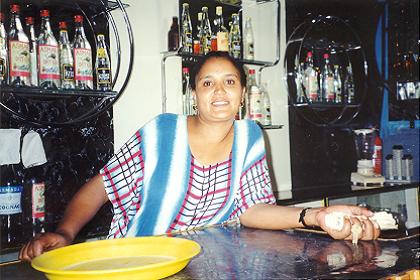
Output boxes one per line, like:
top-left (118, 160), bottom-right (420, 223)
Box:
top-left (162, 0), bottom-right (282, 129)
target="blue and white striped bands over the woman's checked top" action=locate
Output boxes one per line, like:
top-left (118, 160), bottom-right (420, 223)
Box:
top-left (126, 114), bottom-right (265, 237)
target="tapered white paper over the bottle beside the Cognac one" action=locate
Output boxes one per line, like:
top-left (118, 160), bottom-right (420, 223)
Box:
top-left (22, 130), bottom-right (47, 168)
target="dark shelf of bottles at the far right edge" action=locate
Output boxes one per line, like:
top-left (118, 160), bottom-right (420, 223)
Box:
top-left (388, 0), bottom-right (420, 120)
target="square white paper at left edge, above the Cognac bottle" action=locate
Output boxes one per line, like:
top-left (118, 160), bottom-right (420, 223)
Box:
top-left (0, 128), bottom-right (21, 165)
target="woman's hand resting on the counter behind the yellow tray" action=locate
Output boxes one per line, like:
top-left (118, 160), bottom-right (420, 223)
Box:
top-left (19, 232), bottom-right (72, 262)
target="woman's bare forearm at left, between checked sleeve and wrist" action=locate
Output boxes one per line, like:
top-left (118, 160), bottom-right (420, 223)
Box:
top-left (56, 175), bottom-right (108, 241)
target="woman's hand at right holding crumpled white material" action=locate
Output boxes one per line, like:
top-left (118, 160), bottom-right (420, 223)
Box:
top-left (315, 205), bottom-right (380, 240)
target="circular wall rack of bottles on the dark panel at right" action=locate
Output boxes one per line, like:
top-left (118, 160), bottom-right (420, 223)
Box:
top-left (284, 16), bottom-right (368, 125)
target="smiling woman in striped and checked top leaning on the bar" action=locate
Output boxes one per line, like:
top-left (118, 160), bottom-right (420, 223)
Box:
top-left (19, 52), bottom-right (379, 260)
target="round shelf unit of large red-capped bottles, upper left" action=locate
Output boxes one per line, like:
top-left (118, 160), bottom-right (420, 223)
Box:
top-left (0, 0), bottom-right (132, 125)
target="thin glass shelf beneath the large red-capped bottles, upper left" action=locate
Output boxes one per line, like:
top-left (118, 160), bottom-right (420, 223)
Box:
top-left (0, 85), bottom-right (118, 99)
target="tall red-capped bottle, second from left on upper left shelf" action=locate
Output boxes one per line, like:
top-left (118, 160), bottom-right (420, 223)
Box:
top-left (8, 4), bottom-right (31, 86)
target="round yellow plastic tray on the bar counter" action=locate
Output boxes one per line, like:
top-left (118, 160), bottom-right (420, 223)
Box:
top-left (31, 236), bottom-right (201, 280)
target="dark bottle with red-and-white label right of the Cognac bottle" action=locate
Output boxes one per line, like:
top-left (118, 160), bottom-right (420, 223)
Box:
top-left (23, 166), bottom-right (45, 238)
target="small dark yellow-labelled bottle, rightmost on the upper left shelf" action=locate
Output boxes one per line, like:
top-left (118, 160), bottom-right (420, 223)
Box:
top-left (95, 34), bottom-right (111, 91)
